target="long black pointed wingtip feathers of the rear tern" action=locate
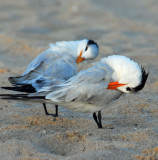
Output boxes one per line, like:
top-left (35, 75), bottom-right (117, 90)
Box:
top-left (1, 84), bottom-right (36, 93)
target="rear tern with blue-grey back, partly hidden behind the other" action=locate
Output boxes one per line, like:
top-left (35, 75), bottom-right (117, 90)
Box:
top-left (2, 39), bottom-right (99, 117)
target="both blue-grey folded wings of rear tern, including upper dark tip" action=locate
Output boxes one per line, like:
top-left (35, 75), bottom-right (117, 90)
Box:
top-left (9, 50), bottom-right (77, 91)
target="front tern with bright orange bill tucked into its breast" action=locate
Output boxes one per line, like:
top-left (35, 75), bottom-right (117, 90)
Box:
top-left (0, 55), bottom-right (149, 128)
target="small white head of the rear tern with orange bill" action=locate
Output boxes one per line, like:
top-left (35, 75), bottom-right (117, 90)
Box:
top-left (76, 39), bottom-right (99, 64)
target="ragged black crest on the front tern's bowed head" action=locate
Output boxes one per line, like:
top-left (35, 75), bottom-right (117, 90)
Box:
top-left (132, 67), bottom-right (149, 92)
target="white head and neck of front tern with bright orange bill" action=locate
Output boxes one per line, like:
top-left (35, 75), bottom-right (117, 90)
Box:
top-left (105, 55), bottom-right (149, 93)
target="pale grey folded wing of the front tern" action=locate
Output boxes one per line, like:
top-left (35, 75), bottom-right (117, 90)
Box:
top-left (46, 64), bottom-right (112, 102)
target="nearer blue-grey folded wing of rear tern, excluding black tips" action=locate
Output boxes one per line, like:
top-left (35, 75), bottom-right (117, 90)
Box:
top-left (23, 57), bottom-right (77, 91)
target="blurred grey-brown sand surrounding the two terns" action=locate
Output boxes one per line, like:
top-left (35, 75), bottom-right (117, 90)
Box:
top-left (0, 0), bottom-right (158, 160)
